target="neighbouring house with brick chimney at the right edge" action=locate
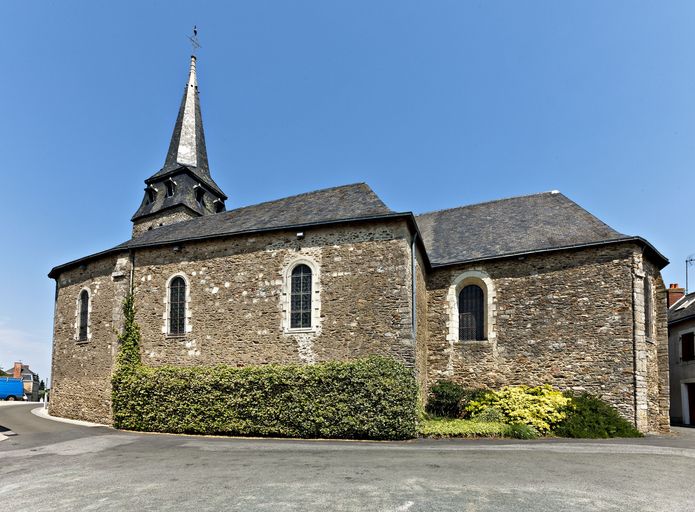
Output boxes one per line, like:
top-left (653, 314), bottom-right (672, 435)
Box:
top-left (668, 284), bottom-right (695, 425)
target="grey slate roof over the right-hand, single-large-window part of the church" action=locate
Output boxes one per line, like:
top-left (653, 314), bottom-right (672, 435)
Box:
top-left (416, 192), bottom-right (634, 266)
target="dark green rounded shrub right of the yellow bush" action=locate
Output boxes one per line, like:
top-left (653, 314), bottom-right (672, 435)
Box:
top-left (553, 392), bottom-right (642, 438)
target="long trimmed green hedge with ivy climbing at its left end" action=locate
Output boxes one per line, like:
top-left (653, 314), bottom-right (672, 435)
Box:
top-left (112, 296), bottom-right (417, 439)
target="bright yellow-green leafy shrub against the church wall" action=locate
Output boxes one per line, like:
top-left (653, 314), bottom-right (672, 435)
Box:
top-left (466, 385), bottom-right (570, 434)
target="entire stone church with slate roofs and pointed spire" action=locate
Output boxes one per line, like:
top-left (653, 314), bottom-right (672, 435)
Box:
top-left (49, 57), bottom-right (669, 432)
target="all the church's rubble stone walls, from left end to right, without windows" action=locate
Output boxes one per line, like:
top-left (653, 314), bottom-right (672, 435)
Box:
top-left (50, 221), bottom-right (669, 431)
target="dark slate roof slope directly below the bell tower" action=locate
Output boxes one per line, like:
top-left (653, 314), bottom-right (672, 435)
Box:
top-left (117, 183), bottom-right (392, 249)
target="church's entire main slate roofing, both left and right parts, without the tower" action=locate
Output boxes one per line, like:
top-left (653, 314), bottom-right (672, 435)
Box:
top-left (49, 183), bottom-right (668, 277)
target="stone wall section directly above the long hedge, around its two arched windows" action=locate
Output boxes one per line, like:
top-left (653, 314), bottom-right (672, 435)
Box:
top-left (135, 222), bottom-right (415, 366)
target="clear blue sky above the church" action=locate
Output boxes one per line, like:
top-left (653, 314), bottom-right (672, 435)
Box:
top-left (0, 0), bottom-right (695, 376)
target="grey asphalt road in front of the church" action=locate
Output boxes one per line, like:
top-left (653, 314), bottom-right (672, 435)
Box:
top-left (0, 403), bottom-right (695, 512)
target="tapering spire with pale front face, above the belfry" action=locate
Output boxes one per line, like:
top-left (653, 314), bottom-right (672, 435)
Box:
top-left (164, 55), bottom-right (210, 175)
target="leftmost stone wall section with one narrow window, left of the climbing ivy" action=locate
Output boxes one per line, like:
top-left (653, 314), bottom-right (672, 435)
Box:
top-left (49, 253), bottom-right (130, 424)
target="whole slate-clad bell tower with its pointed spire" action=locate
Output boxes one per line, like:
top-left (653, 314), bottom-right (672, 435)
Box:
top-left (131, 55), bottom-right (227, 237)
